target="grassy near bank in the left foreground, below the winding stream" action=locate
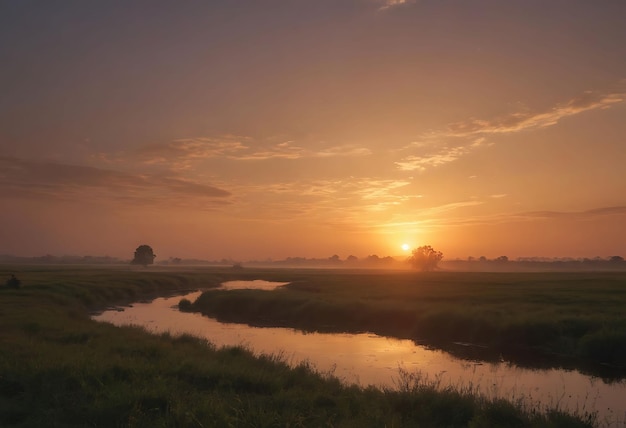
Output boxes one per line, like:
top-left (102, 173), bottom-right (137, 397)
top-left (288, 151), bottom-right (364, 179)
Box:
top-left (0, 268), bottom-right (594, 428)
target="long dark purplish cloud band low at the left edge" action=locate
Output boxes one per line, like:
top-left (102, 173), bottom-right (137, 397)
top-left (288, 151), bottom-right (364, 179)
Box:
top-left (0, 157), bottom-right (231, 206)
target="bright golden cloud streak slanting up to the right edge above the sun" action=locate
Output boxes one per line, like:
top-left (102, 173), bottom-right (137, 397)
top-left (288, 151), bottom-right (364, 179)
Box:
top-left (395, 86), bottom-right (626, 171)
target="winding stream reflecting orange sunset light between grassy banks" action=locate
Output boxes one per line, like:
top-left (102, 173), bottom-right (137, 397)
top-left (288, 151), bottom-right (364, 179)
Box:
top-left (93, 281), bottom-right (626, 428)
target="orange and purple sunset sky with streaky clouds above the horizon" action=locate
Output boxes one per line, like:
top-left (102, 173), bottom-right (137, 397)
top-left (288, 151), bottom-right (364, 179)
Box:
top-left (0, 0), bottom-right (626, 261)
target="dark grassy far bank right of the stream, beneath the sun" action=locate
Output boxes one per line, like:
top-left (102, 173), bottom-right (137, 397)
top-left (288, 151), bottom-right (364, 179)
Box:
top-left (190, 271), bottom-right (626, 377)
